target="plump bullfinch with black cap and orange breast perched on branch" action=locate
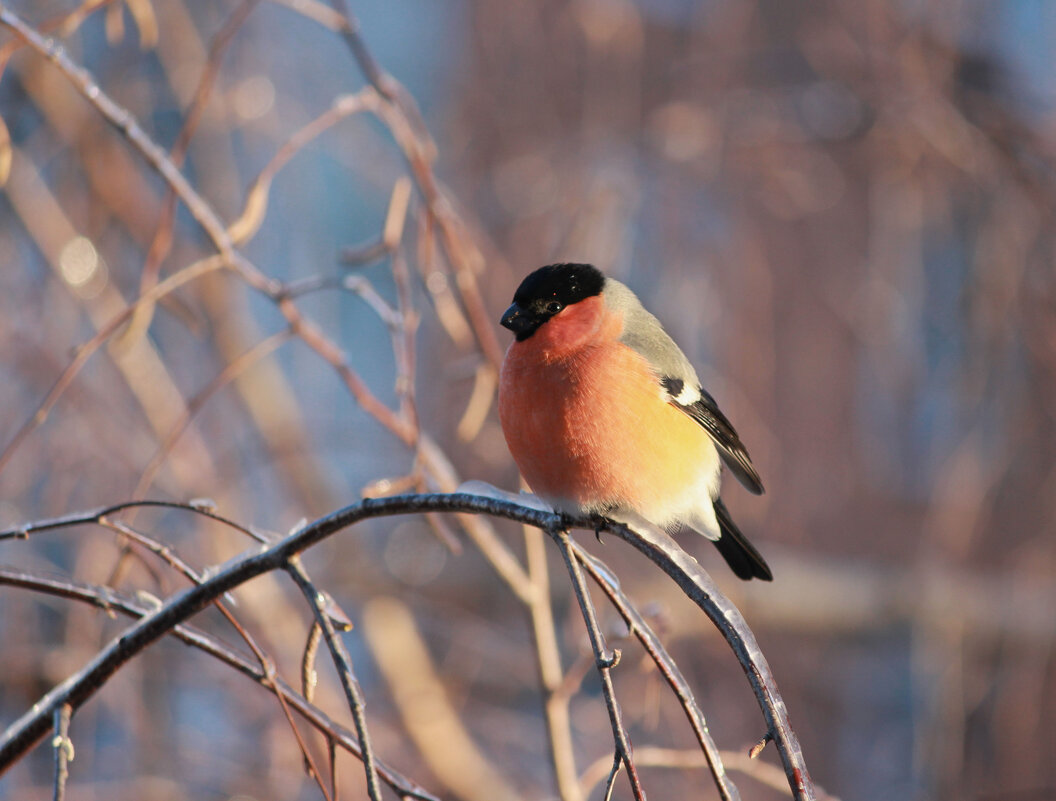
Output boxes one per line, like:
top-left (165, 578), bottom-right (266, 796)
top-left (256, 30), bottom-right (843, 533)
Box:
top-left (498, 264), bottom-right (773, 581)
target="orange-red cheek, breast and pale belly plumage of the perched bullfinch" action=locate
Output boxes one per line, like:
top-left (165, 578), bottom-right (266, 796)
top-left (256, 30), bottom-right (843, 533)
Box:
top-left (498, 297), bottom-right (718, 525)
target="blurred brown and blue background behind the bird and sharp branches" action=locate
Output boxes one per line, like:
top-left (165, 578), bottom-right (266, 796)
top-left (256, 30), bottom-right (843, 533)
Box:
top-left (0, 0), bottom-right (1056, 801)
